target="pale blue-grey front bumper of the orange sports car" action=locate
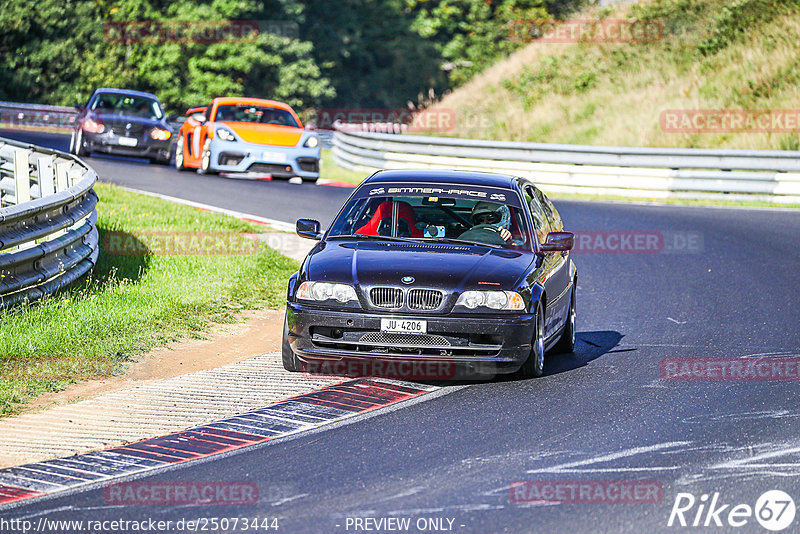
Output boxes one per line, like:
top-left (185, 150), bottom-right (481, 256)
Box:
top-left (210, 137), bottom-right (321, 180)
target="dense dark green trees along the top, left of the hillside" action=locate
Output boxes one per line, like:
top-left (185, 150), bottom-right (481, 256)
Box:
top-left (0, 0), bottom-right (581, 112)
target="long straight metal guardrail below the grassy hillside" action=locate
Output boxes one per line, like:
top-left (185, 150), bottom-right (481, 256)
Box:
top-left (333, 130), bottom-right (800, 203)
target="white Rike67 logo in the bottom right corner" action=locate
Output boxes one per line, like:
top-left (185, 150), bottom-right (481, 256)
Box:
top-left (667, 490), bottom-right (796, 532)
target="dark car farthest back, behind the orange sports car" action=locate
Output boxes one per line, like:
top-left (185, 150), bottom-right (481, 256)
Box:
top-left (70, 89), bottom-right (175, 164)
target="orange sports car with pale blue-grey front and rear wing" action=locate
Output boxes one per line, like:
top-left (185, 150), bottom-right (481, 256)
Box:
top-left (175, 97), bottom-right (320, 179)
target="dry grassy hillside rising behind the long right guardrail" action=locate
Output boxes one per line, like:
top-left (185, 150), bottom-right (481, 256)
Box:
top-left (320, 0), bottom-right (800, 207)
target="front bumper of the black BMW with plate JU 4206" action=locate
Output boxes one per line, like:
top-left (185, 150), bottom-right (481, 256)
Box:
top-left (286, 302), bottom-right (535, 378)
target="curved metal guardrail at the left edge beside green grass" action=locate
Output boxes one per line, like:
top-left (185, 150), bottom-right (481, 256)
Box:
top-left (0, 138), bottom-right (99, 307)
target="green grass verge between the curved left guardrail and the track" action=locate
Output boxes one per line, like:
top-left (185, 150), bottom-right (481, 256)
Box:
top-left (0, 184), bottom-right (298, 415)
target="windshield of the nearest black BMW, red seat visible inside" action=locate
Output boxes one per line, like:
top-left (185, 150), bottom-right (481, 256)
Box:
top-left (328, 191), bottom-right (530, 249)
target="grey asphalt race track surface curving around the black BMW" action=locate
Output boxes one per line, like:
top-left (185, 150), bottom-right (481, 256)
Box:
top-left (0, 133), bottom-right (800, 533)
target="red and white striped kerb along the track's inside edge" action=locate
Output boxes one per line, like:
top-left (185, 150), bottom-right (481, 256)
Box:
top-left (0, 378), bottom-right (440, 506)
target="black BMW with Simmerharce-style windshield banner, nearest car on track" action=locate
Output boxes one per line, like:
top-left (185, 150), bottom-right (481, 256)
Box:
top-left (283, 171), bottom-right (577, 379)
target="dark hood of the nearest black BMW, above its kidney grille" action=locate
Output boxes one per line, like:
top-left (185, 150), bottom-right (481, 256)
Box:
top-left (306, 240), bottom-right (535, 292)
